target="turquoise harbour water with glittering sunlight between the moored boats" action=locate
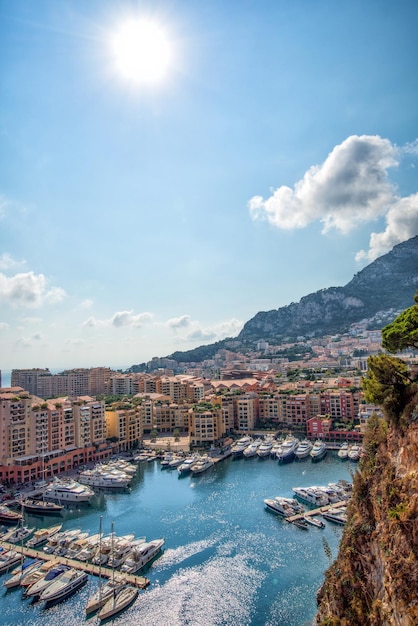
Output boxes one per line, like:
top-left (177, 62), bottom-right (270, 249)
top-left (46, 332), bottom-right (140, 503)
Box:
top-left (0, 453), bottom-right (354, 626)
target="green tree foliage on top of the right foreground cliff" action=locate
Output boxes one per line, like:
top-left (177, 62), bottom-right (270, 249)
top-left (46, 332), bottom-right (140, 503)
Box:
top-left (363, 291), bottom-right (418, 422)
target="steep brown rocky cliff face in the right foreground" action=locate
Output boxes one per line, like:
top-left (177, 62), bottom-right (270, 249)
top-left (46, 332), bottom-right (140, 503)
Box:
top-left (316, 408), bottom-right (418, 626)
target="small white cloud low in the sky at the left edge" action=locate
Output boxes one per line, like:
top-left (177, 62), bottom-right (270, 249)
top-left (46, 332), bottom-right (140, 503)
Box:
top-left (0, 272), bottom-right (66, 308)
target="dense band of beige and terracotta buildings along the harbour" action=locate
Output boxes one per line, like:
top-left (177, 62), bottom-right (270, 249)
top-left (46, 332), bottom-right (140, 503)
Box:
top-left (0, 325), bottom-right (416, 486)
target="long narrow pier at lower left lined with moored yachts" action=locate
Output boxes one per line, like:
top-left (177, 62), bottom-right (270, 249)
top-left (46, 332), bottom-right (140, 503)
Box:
top-left (0, 541), bottom-right (150, 589)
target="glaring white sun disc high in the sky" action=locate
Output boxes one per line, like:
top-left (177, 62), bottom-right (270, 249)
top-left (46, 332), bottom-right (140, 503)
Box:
top-left (112, 19), bottom-right (172, 83)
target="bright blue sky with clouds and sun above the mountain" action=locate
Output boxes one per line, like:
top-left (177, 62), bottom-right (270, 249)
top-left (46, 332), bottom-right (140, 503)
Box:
top-left (0, 0), bottom-right (418, 370)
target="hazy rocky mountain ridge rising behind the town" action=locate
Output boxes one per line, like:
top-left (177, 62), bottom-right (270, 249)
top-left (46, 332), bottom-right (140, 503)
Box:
top-left (238, 236), bottom-right (418, 343)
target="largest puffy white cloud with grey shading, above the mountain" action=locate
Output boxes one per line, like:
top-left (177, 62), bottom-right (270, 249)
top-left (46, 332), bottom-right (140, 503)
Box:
top-left (249, 135), bottom-right (398, 233)
